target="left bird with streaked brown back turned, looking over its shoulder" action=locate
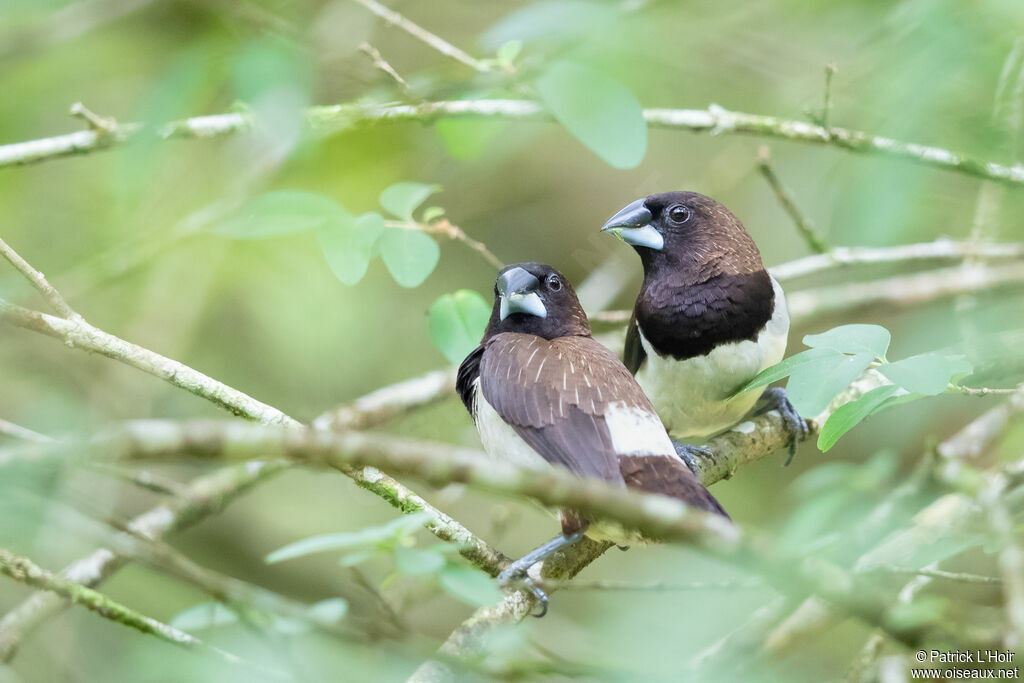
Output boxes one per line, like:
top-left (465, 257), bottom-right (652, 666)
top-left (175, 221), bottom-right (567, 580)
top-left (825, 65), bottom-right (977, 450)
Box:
top-left (456, 262), bottom-right (729, 615)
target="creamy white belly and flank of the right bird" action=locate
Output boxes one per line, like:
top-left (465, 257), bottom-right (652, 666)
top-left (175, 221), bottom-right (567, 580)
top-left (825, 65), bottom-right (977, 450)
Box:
top-left (636, 278), bottom-right (790, 438)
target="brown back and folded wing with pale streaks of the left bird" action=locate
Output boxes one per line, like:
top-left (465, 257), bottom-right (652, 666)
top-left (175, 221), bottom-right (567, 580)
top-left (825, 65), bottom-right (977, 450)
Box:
top-left (479, 333), bottom-right (653, 483)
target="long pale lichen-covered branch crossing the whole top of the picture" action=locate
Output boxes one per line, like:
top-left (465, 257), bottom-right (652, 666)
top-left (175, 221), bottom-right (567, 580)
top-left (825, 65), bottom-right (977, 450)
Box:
top-left (6, 99), bottom-right (1024, 185)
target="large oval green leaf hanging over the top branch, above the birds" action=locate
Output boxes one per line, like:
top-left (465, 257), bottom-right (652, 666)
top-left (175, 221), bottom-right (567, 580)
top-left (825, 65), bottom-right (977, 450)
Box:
top-left (535, 61), bottom-right (647, 169)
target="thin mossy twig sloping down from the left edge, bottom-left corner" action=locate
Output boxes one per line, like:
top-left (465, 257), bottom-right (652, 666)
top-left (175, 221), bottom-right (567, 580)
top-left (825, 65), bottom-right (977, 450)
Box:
top-left (0, 548), bottom-right (268, 666)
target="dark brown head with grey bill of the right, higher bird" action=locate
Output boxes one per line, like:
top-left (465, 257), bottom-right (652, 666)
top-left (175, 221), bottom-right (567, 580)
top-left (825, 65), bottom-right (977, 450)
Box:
top-left (601, 191), bottom-right (764, 282)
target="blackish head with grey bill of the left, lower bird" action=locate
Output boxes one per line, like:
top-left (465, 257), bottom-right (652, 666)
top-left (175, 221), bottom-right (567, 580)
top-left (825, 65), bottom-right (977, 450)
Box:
top-left (483, 262), bottom-right (590, 340)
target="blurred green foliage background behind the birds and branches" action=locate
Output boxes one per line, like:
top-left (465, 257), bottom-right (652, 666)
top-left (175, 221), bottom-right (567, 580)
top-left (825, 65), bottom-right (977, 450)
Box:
top-left (0, 0), bottom-right (1024, 681)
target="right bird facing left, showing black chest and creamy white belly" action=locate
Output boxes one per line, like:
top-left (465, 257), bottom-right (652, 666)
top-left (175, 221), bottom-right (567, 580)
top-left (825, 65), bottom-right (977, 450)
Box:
top-left (601, 191), bottom-right (809, 467)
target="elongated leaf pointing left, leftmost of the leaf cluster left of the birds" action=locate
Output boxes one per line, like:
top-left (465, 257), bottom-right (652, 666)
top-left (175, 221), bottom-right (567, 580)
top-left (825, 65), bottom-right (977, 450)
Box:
top-left (213, 189), bottom-right (351, 240)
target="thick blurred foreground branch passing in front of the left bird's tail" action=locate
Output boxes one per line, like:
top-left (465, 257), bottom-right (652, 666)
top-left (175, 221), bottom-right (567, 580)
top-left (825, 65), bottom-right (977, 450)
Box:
top-left (6, 420), bottom-right (966, 645)
